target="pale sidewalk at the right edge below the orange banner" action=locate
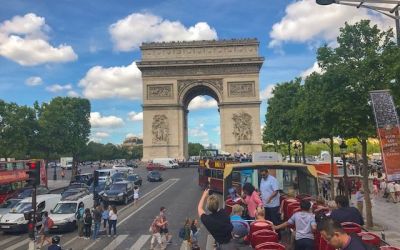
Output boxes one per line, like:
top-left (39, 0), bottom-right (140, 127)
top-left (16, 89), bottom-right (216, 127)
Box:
top-left (352, 195), bottom-right (400, 247)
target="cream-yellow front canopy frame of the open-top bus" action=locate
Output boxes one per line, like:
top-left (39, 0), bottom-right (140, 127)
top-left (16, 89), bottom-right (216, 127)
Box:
top-left (224, 161), bottom-right (318, 179)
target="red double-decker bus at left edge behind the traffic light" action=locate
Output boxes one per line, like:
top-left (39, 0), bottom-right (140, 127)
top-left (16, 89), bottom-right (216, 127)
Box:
top-left (0, 160), bottom-right (47, 204)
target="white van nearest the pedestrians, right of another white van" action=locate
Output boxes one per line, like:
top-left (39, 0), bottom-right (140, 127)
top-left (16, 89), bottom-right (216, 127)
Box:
top-left (49, 193), bottom-right (93, 231)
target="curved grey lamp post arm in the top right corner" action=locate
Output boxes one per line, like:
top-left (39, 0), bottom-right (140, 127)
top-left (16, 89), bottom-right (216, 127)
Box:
top-left (316, 0), bottom-right (400, 46)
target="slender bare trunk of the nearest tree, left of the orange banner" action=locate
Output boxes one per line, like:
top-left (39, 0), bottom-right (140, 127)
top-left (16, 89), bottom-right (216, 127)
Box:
top-left (361, 139), bottom-right (374, 228)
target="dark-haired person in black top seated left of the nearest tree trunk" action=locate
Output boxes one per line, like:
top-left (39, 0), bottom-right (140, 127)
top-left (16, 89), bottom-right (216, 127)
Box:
top-left (330, 195), bottom-right (364, 226)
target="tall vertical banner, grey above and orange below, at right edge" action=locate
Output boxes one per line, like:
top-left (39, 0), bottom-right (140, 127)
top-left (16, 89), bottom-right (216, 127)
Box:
top-left (370, 90), bottom-right (400, 181)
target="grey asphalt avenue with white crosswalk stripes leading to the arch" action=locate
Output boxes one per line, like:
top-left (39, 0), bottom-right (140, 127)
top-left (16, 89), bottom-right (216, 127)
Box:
top-left (0, 167), bottom-right (208, 250)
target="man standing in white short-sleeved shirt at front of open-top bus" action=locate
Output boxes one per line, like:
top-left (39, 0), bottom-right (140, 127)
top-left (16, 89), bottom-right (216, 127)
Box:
top-left (260, 170), bottom-right (280, 232)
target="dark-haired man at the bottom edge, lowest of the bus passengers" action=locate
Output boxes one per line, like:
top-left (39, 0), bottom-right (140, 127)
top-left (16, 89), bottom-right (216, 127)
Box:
top-left (317, 218), bottom-right (370, 250)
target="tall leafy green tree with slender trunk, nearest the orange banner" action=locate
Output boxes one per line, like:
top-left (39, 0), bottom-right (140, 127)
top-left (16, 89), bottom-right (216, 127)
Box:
top-left (317, 20), bottom-right (396, 227)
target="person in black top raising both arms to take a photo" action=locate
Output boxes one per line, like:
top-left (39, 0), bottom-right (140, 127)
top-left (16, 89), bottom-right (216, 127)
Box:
top-left (197, 189), bottom-right (234, 250)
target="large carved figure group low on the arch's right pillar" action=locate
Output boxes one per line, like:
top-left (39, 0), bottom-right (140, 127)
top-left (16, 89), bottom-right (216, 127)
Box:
top-left (232, 112), bottom-right (253, 141)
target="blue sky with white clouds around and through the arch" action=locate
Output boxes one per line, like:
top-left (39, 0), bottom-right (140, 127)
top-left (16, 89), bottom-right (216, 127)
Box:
top-left (0, 0), bottom-right (392, 146)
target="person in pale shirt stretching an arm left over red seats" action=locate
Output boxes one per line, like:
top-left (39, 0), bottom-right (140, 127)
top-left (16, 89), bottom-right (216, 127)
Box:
top-left (274, 200), bottom-right (317, 250)
